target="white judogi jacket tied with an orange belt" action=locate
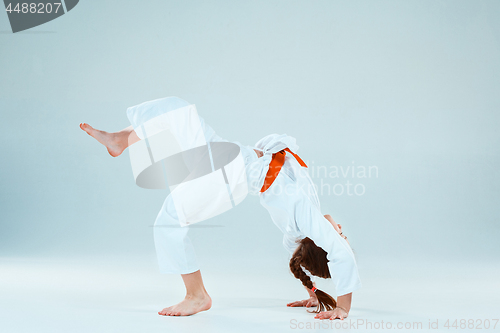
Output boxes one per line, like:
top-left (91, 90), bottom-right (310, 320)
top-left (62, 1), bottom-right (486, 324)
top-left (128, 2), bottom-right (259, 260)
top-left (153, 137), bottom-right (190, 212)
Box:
top-left (252, 134), bottom-right (361, 296)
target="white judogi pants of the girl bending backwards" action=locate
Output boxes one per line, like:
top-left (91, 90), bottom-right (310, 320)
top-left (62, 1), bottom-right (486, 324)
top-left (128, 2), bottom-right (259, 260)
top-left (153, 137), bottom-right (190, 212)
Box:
top-left (127, 96), bottom-right (257, 274)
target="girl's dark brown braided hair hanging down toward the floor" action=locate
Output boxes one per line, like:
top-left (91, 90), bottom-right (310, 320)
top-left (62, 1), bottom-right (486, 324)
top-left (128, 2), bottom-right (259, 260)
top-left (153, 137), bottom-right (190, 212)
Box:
top-left (290, 237), bottom-right (337, 313)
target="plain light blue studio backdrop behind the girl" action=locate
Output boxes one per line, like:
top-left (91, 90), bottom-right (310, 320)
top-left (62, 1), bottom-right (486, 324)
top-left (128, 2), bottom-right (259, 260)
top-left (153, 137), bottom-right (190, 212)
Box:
top-left (0, 0), bottom-right (500, 267)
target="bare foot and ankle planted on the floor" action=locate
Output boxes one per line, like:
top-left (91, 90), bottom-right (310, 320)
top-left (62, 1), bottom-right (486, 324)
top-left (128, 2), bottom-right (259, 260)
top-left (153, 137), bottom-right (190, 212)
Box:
top-left (158, 270), bottom-right (212, 316)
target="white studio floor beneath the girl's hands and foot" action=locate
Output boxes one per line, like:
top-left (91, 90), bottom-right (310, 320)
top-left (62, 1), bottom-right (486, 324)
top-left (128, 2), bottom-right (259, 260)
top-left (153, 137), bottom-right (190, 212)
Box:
top-left (0, 257), bottom-right (500, 333)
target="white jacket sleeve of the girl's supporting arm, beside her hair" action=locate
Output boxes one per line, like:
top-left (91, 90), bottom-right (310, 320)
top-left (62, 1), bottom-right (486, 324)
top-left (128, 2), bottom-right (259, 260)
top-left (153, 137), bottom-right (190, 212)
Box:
top-left (295, 198), bottom-right (361, 296)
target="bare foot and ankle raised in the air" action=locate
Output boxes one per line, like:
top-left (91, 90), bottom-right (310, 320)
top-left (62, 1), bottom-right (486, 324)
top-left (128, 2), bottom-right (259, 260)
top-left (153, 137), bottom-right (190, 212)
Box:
top-left (80, 123), bottom-right (141, 157)
